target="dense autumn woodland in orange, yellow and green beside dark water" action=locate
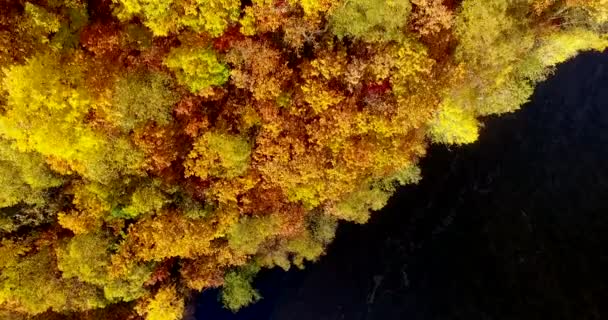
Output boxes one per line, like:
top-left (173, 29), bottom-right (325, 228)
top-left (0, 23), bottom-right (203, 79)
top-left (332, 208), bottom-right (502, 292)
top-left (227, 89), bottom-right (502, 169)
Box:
top-left (0, 0), bottom-right (608, 320)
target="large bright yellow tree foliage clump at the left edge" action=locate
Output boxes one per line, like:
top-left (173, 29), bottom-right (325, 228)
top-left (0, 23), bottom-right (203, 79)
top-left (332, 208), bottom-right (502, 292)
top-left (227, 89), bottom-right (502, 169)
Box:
top-left (0, 55), bottom-right (146, 182)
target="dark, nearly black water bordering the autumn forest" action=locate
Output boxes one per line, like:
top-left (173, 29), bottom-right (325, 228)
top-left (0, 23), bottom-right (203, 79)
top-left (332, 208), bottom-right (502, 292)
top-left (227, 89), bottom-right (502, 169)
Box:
top-left (195, 53), bottom-right (608, 320)
